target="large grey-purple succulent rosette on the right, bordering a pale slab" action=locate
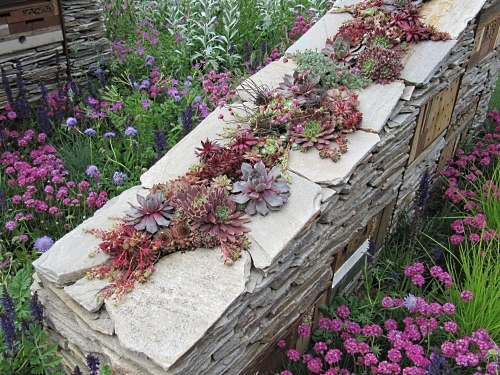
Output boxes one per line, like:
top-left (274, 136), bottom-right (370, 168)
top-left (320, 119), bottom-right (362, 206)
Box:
top-left (231, 161), bottom-right (290, 216)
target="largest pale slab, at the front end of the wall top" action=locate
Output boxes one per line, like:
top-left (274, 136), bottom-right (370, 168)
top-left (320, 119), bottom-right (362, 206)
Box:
top-left (105, 249), bottom-right (251, 373)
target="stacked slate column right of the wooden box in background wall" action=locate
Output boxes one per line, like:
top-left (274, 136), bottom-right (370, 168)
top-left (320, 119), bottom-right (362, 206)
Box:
top-left (61, 0), bottom-right (109, 78)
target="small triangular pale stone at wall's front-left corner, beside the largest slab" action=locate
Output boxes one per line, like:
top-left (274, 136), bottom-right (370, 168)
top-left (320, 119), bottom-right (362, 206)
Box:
top-left (64, 278), bottom-right (110, 312)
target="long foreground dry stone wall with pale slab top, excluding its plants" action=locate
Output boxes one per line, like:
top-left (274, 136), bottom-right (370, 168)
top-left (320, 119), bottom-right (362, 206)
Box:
top-left (32, 0), bottom-right (500, 375)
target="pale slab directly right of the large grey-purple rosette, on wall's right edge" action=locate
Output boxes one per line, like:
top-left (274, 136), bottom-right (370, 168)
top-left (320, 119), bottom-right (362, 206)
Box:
top-left (247, 173), bottom-right (320, 273)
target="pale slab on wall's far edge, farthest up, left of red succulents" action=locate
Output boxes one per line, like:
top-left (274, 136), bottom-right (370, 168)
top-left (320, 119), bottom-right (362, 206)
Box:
top-left (286, 13), bottom-right (352, 53)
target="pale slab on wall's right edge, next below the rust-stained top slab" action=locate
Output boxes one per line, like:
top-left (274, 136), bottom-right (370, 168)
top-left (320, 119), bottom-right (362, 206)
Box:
top-left (401, 40), bottom-right (457, 85)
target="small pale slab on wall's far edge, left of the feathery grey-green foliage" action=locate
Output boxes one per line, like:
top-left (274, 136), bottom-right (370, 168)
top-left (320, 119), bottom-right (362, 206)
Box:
top-left (236, 59), bottom-right (297, 103)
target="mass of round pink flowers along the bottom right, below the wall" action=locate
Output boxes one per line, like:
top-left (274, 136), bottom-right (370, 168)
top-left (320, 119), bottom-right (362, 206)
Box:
top-left (278, 286), bottom-right (484, 375)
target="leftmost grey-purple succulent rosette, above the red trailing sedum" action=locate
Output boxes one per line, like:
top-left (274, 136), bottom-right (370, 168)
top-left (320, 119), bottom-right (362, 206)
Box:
top-left (123, 192), bottom-right (173, 234)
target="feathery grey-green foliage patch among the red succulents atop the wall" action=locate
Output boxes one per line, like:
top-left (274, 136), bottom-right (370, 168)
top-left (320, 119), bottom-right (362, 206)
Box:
top-left (289, 50), bottom-right (371, 90)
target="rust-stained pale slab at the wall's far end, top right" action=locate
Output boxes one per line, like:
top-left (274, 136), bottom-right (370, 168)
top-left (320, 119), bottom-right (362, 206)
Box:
top-left (420, 0), bottom-right (485, 39)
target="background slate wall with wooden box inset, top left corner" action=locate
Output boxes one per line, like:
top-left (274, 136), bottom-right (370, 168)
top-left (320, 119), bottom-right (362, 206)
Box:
top-left (0, 0), bottom-right (109, 110)
